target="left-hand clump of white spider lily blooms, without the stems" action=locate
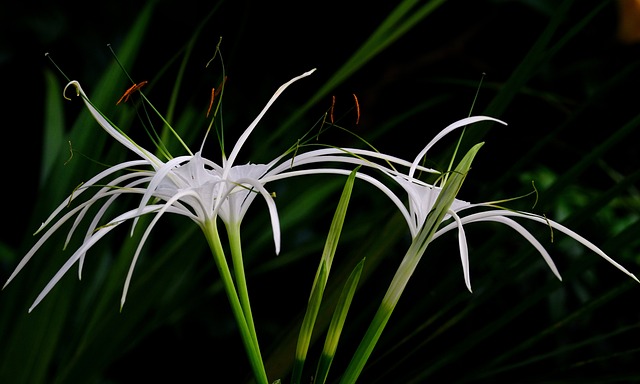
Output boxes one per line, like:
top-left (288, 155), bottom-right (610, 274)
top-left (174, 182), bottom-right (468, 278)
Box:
top-left (3, 69), bottom-right (315, 311)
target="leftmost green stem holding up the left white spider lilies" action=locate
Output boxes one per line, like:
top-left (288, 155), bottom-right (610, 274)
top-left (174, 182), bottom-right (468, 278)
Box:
top-left (202, 220), bottom-right (269, 384)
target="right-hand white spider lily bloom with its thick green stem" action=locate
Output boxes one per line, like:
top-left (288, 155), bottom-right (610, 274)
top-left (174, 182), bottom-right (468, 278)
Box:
top-left (342, 117), bottom-right (640, 383)
